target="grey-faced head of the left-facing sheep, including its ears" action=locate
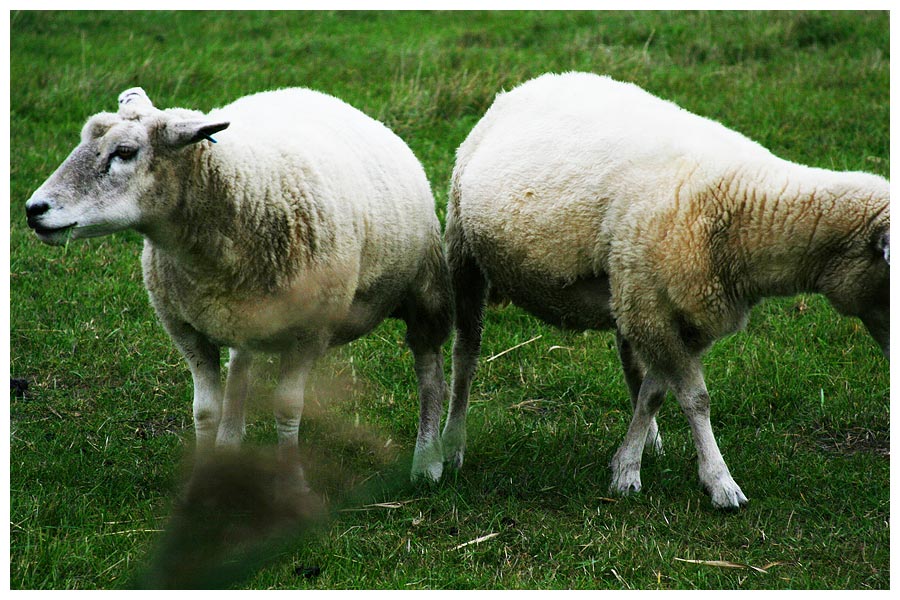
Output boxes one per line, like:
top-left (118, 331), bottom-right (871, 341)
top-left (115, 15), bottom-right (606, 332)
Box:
top-left (25, 88), bottom-right (228, 245)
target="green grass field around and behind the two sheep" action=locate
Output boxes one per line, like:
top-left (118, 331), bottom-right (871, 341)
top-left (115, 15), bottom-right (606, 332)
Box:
top-left (9, 11), bottom-right (890, 589)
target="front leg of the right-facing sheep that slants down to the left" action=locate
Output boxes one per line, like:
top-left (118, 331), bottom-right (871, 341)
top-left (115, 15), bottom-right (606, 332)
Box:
top-left (610, 373), bottom-right (666, 495)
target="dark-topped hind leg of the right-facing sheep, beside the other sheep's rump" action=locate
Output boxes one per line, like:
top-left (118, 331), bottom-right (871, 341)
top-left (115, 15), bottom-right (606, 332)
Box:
top-left (441, 219), bottom-right (487, 469)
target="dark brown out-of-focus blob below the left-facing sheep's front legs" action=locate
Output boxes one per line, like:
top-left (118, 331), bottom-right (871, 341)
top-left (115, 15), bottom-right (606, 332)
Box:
top-left (137, 451), bottom-right (328, 589)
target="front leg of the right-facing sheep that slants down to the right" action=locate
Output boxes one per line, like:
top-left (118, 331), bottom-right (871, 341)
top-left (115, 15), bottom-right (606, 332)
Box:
top-left (675, 367), bottom-right (747, 508)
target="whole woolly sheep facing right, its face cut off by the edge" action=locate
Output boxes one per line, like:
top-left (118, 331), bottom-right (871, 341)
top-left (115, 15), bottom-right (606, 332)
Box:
top-left (442, 73), bottom-right (890, 508)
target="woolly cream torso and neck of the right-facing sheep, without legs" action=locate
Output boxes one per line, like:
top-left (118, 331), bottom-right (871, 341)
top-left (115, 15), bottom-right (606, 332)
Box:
top-left (448, 73), bottom-right (889, 351)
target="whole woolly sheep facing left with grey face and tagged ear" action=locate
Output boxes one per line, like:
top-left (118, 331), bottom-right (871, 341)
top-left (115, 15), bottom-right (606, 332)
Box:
top-left (26, 88), bottom-right (452, 480)
